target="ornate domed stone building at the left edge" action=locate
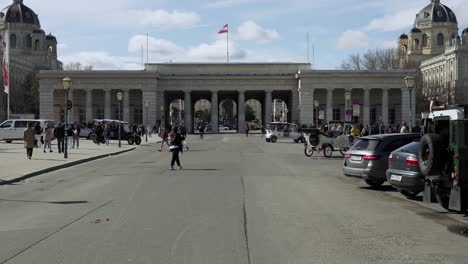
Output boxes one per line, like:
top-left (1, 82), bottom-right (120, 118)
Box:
top-left (0, 0), bottom-right (62, 120)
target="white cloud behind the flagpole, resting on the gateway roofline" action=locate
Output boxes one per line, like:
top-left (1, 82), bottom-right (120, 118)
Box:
top-left (187, 39), bottom-right (247, 61)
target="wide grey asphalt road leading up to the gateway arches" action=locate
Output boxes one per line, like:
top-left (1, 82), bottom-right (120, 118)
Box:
top-left (0, 135), bottom-right (468, 264)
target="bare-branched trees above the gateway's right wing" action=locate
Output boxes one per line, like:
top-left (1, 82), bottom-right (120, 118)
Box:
top-left (340, 48), bottom-right (400, 71)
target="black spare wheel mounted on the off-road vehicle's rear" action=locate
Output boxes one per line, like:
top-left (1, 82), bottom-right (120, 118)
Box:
top-left (419, 134), bottom-right (443, 175)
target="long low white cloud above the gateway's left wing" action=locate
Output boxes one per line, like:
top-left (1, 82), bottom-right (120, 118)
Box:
top-left (60, 51), bottom-right (142, 70)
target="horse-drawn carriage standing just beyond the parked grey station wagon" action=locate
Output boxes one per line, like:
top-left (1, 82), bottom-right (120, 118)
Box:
top-left (303, 121), bottom-right (354, 158)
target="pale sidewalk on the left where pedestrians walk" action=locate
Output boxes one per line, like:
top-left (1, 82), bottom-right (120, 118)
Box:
top-left (0, 136), bottom-right (160, 185)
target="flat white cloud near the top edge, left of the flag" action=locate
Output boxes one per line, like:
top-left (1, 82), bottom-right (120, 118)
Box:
top-left (131, 9), bottom-right (200, 28)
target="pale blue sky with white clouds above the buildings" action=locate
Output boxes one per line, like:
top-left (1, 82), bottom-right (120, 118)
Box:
top-left (4, 0), bottom-right (468, 69)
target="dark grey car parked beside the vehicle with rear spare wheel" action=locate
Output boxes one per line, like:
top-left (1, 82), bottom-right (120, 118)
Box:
top-left (387, 142), bottom-right (424, 198)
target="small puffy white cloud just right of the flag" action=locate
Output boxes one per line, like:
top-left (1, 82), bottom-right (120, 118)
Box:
top-left (235, 20), bottom-right (280, 42)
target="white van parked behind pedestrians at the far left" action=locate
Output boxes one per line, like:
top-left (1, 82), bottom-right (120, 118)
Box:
top-left (0, 119), bottom-right (55, 143)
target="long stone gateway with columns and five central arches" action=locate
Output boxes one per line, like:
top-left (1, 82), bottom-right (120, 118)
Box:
top-left (39, 63), bottom-right (415, 132)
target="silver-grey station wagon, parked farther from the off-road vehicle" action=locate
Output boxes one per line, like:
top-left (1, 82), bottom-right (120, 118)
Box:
top-left (343, 134), bottom-right (421, 187)
